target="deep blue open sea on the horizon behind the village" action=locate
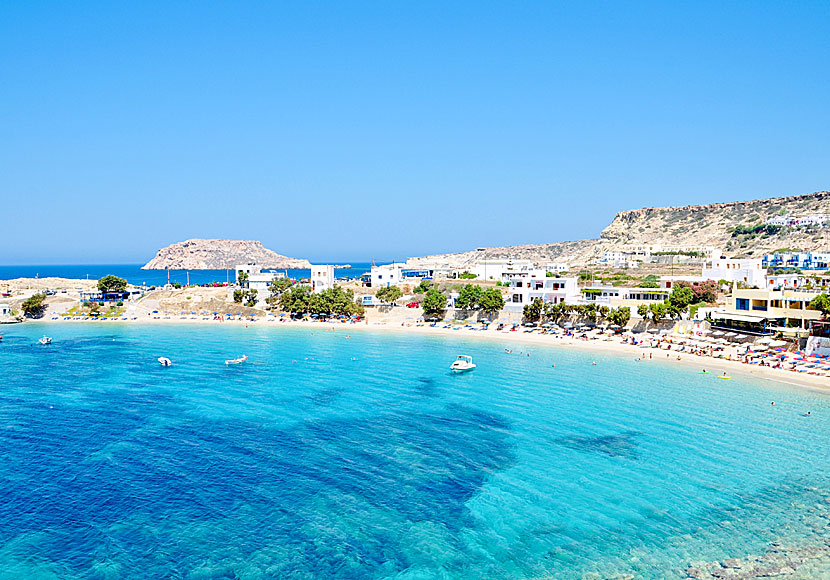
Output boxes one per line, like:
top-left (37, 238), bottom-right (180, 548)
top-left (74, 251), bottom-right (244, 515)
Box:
top-left (0, 262), bottom-right (371, 286)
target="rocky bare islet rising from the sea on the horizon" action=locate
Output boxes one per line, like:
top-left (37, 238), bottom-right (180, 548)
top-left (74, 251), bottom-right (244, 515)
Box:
top-left (142, 240), bottom-right (311, 270)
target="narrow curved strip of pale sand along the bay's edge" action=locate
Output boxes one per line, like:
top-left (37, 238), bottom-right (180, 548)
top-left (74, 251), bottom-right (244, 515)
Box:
top-left (21, 317), bottom-right (830, 393)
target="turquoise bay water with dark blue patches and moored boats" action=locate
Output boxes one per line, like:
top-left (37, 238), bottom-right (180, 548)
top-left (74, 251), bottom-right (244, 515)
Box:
top-left (0, 323), bottom-right (830, 580)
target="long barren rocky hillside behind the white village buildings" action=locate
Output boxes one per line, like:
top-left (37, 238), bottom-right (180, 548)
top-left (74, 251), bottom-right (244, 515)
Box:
top-left (409, 191), bottom-right (830, 267)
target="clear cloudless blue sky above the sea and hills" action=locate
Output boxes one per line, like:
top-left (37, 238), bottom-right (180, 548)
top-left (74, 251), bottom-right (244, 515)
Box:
top-left (0, 1), bottom-right (830, 264)
